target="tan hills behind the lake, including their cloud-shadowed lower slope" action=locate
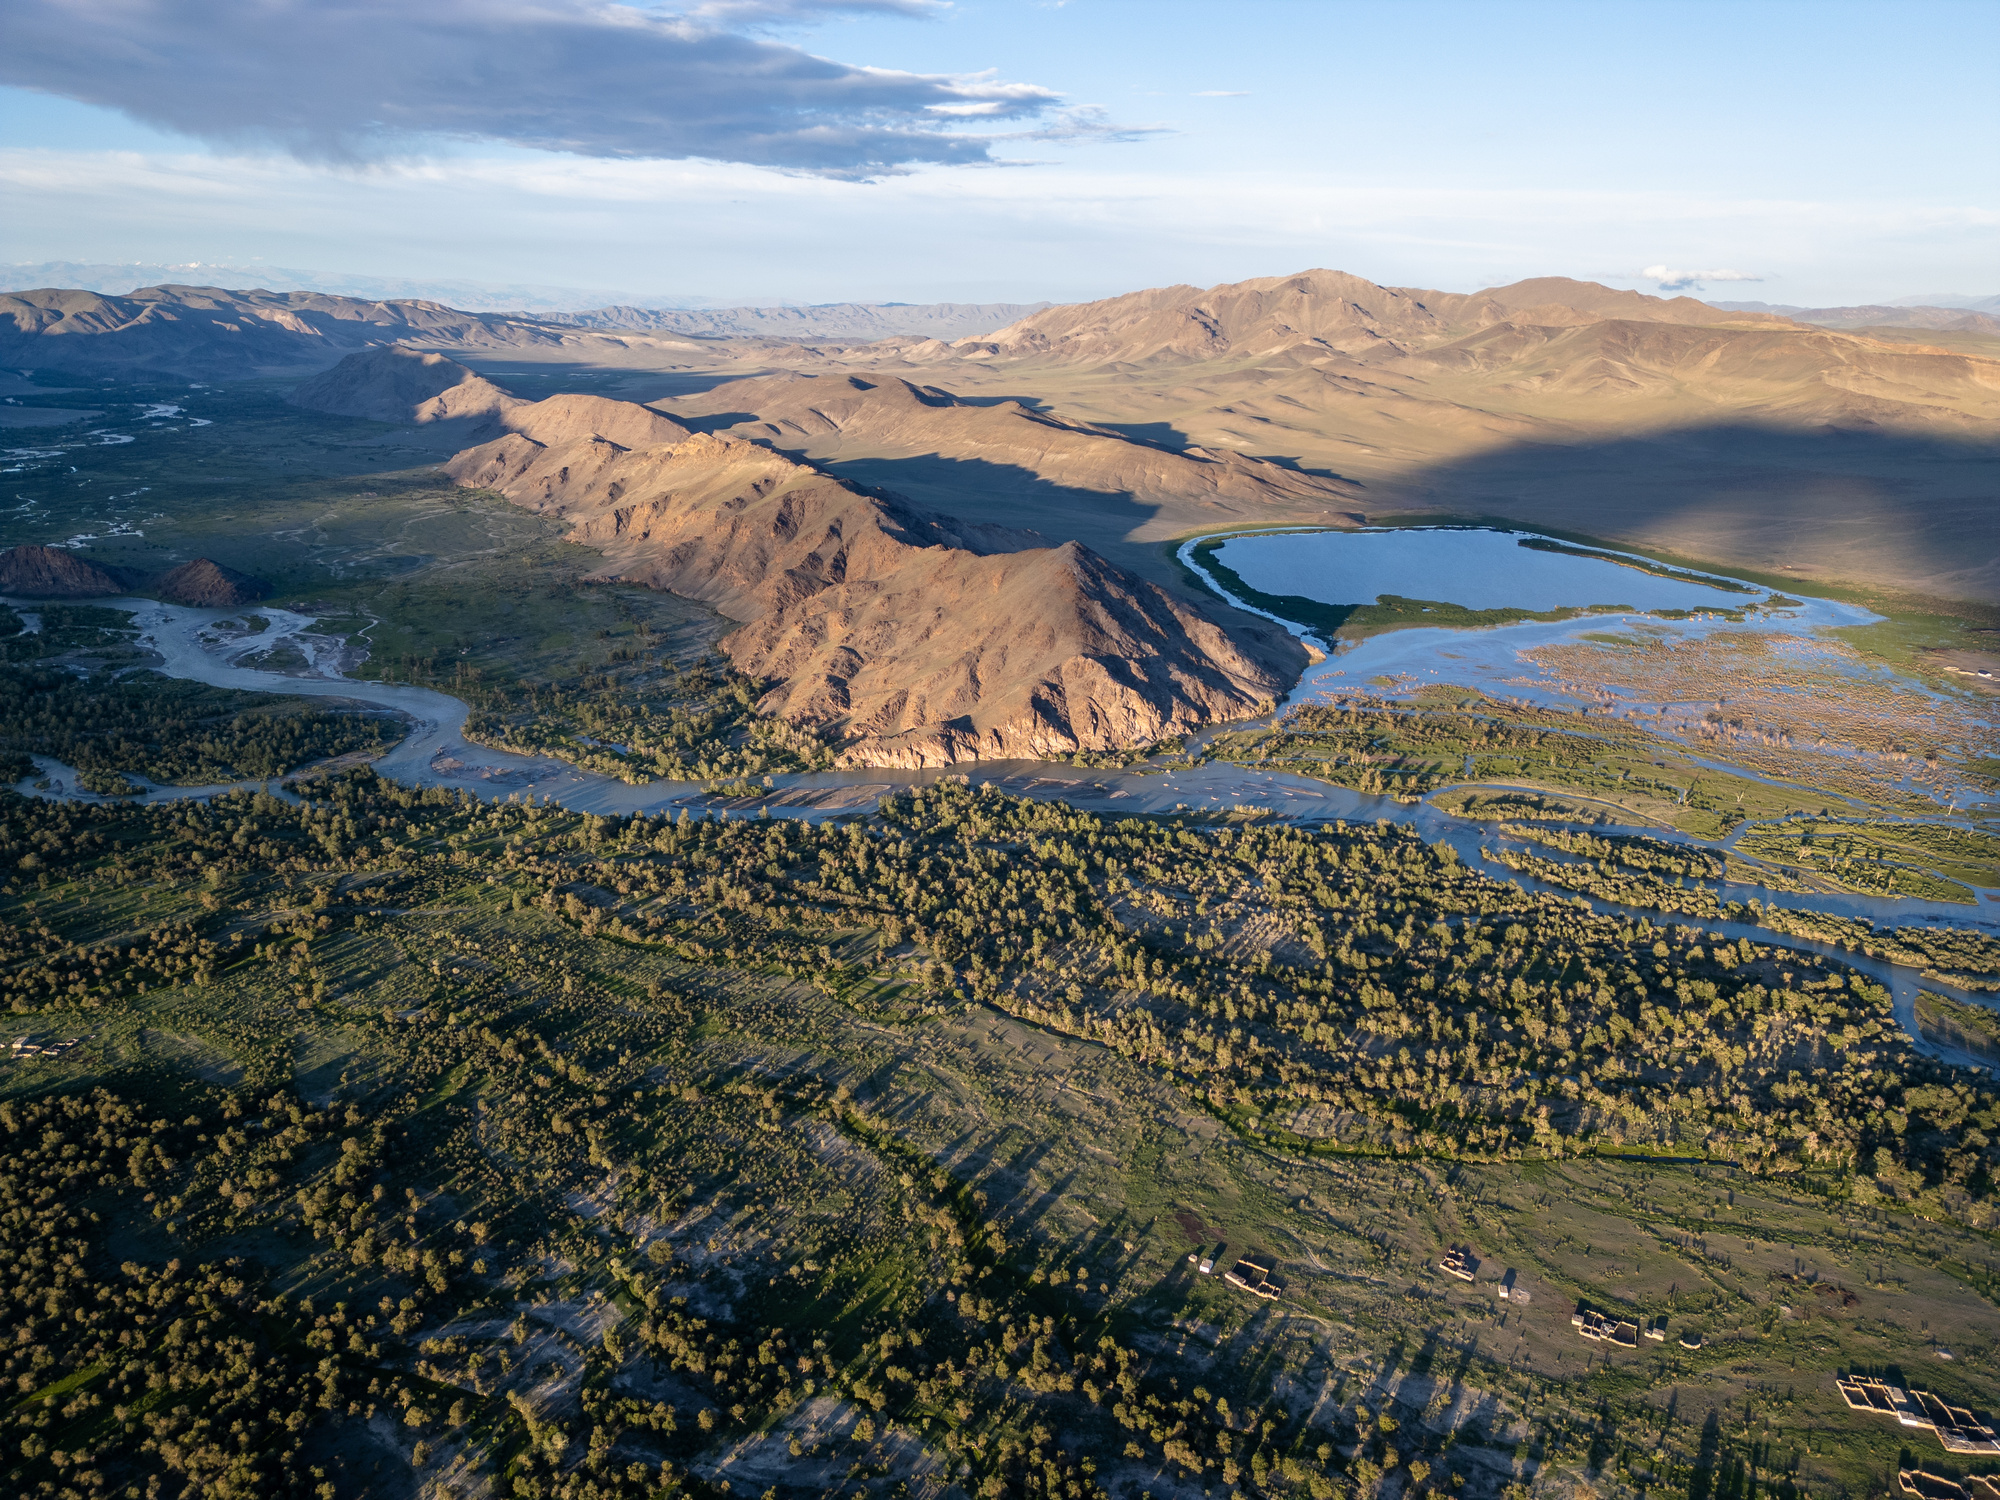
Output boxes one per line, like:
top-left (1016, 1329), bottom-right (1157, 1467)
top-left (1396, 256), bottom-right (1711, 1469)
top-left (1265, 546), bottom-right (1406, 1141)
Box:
top-left (740, 270), bottom-right (2000, 602)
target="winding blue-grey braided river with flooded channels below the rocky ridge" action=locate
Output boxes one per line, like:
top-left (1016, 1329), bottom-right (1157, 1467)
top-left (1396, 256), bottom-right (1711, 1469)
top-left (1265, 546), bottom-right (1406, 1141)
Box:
top-left (15, 532), bottom-right (2000, 1068)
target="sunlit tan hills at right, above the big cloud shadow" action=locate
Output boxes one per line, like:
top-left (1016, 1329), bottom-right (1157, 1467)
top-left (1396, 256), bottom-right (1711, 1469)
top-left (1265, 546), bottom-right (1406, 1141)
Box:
top-left (816, 270), bottom-right (2000, 434)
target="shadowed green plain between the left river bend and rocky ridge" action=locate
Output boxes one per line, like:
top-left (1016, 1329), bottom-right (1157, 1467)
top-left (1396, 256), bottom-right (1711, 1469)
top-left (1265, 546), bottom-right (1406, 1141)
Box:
top-left (0, 384), bottom-right (826, 780)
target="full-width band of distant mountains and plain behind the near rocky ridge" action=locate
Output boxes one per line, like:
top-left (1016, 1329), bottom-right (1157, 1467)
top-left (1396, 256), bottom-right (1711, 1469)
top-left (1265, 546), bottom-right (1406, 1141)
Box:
top-left (15, 270), bottom-right (2000, 602)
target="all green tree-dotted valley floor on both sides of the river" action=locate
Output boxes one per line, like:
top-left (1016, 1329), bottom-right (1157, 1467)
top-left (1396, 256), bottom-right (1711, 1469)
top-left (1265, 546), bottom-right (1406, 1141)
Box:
top-left (0, 378), bottom-right (2000, 1500)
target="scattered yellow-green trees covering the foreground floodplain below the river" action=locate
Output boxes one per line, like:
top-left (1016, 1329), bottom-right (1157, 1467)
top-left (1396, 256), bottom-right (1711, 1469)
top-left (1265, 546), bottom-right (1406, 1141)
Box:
top-left (0, 770), bottom-right (2000, 1500)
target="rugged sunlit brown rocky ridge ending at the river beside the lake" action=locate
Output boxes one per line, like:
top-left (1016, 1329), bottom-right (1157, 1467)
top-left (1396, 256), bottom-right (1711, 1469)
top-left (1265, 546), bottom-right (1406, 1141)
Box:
top-left (448, 428), bottom-right (1304, 766)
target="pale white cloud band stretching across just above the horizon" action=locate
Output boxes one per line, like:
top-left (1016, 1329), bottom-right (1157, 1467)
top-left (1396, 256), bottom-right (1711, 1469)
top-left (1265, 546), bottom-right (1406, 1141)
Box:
top-left (0, 146), bottom-right (2000, 306)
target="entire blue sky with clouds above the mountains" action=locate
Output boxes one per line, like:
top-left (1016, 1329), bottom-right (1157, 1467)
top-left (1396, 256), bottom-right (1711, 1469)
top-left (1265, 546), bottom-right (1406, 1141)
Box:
top-left (0, 0), bottom-right (2000, 304)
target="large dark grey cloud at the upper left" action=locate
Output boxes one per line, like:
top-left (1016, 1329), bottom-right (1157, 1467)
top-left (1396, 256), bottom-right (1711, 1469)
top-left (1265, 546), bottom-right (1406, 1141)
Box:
top-left (0, 0), bottom-right (1126, 178)
